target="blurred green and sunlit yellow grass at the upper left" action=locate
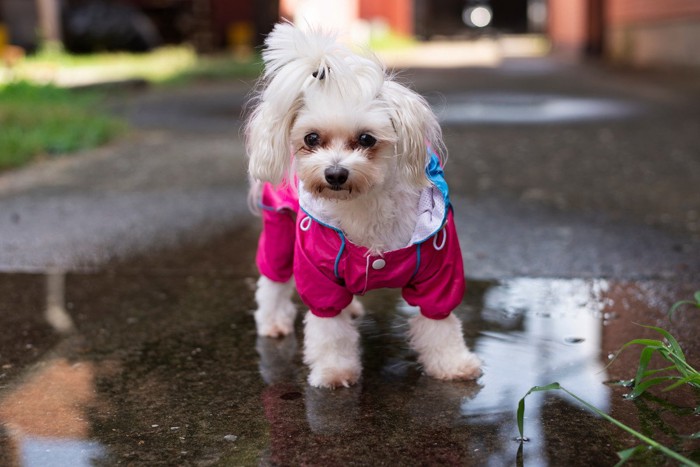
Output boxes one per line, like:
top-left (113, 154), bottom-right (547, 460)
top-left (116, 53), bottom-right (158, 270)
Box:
top-left (0, 46), bottom-right (262, 170)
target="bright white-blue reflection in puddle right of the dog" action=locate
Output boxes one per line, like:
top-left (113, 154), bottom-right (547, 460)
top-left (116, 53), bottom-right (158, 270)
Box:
top-left (461, 279), bottom-right (610, 465)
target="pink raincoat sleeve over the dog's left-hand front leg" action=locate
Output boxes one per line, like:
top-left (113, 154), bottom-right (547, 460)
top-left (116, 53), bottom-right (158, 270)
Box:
top-left (294, 215), bottom-right (353, 318)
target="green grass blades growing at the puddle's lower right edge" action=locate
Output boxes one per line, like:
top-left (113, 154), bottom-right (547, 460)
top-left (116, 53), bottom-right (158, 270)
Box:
top-left (517, 291), bottom-right (700, 467)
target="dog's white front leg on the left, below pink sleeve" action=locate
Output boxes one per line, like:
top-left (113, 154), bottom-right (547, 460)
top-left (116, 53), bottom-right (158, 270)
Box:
top-left (304, 309), bottom-right (362, 388)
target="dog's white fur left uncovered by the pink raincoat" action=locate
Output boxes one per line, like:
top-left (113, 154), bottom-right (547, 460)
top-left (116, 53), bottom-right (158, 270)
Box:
top-left (245, 23), bottom-right (478, 387)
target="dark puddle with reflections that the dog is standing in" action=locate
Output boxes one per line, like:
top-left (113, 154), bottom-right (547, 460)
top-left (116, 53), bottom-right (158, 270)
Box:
top-left (0, 232), bottom-right (700, 466)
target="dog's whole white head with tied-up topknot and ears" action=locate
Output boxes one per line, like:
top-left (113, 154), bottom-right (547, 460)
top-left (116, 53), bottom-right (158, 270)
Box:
top-left (246, 23), bottom-right (443, 199)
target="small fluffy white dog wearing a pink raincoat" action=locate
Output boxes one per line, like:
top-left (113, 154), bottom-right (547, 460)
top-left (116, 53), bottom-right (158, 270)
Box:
top-left (246, 23), bottom-right (481, 388)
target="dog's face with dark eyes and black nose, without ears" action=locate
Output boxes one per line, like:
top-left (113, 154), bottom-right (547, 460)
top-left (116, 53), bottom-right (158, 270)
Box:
top-left (290, 92), bottom-right (397, 200)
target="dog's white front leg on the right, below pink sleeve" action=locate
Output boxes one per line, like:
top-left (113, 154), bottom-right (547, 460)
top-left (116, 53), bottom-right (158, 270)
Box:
top-left (409, 315), bottom-right (481, 380)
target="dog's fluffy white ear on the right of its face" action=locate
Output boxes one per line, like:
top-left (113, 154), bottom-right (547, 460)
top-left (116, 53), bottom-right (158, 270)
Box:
top-left (381, 80), bottom-right (444, 187)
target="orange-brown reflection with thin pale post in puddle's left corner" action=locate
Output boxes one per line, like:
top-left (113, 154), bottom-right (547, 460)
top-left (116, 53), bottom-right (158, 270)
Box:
top-left (0, 270), bottom-right (105, 467)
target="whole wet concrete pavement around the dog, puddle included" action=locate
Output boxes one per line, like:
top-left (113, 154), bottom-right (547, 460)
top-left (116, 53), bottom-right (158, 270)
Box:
top-left (0, 50), bottom-right (700, 466)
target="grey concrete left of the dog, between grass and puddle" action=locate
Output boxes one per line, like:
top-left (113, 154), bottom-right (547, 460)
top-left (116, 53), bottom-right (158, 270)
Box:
top-left (0, 81), bottom-right (250, 271)
